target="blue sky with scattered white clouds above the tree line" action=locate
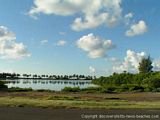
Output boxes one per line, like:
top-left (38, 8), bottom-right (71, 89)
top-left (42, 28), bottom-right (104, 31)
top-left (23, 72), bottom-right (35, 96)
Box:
top-left (0, 0), bottom-right (160, 76)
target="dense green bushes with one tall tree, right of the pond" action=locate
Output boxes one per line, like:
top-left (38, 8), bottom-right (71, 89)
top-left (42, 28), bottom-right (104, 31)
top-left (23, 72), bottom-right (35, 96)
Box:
top-left (93, 57), bottom-right (160, 92)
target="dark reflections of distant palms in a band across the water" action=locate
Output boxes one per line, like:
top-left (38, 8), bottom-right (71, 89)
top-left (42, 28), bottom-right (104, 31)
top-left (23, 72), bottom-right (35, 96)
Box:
top-left (7, 80), bottom-right (91, 86)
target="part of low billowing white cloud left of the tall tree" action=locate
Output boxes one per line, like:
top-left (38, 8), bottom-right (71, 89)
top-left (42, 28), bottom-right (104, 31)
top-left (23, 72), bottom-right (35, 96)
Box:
top-left (113, 50), bottom-right (147, 73)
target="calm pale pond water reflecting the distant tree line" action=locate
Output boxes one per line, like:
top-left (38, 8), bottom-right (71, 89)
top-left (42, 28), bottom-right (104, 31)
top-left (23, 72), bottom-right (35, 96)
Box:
top-left (6, 79), bottom-right (94, 91)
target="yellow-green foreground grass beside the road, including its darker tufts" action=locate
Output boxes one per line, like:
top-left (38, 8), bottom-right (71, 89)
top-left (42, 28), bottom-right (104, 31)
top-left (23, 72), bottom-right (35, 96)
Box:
top-left (0, 94), bottom-right (160, 109)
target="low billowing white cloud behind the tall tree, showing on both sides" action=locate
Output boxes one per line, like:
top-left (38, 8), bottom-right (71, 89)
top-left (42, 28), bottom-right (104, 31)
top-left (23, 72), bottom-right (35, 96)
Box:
top-left (112, 50), bottom-right (160, 73)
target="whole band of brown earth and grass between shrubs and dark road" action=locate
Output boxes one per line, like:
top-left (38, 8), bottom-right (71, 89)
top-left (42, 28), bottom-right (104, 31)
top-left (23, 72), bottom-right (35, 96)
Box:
top-left (0, 91), bottom-right (160, 109)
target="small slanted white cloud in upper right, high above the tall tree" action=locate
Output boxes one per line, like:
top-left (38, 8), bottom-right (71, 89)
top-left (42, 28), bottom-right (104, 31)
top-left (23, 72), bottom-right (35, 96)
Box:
top-left (126, 20), bottom-right (148, 37)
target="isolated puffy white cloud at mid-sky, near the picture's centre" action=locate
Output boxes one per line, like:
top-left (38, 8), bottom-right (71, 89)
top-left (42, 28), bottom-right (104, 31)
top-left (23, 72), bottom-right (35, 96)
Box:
top-left (77, 33), bottom-right (115, 58)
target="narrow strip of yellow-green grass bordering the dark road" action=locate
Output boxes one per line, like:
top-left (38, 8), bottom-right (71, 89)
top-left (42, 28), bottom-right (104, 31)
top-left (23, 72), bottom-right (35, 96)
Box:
top-left (0, 97), bottom-right (157, 109)
